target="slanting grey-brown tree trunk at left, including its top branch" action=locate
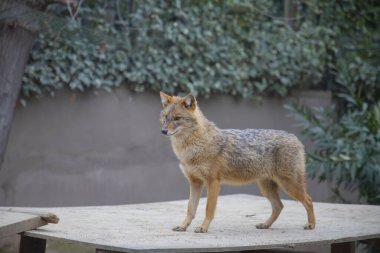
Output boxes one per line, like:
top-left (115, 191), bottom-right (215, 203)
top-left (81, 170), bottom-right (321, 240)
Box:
top-left (0, 0), bottom-right (77, 170)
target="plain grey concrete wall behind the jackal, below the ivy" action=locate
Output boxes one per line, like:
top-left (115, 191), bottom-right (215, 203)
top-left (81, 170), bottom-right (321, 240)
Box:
top-left (0, 88), bottom-right (330, 206)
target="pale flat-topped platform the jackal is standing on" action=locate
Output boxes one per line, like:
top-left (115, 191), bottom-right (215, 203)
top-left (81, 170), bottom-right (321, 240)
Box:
top-left (21, 195), bottom-right (380, 252)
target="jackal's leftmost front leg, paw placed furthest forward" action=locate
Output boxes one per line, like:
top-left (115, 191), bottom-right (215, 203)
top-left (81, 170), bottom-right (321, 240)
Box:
top-left (173, 179), bottom-right (203, 231)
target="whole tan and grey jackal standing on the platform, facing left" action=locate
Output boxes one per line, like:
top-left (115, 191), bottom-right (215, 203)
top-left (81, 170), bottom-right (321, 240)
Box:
top-left (160, 92), bottom-right (315, 233)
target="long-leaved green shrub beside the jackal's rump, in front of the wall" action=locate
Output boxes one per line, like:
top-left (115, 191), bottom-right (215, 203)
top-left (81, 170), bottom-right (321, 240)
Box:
top-left (291, 100), bottom-right (380, 204)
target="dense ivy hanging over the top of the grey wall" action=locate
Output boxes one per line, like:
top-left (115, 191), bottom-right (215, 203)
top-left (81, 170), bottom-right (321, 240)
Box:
top-left (23, 0), bottom-right (326, 98)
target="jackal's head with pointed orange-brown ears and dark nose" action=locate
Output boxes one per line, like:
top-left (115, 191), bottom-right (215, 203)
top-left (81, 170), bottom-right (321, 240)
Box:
top-left (160, 92), bottom-right (197, 136)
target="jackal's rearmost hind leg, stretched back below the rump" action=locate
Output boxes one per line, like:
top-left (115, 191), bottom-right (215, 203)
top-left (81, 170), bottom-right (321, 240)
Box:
top-left (277, 176), bottom-right (315, 230)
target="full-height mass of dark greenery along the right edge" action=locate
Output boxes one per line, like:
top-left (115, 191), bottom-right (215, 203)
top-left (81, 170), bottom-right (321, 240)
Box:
top-left (288, 0), bottom-right (380, 204)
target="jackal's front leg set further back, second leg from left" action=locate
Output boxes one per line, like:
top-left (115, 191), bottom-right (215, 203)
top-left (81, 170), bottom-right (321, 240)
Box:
top-left (195, 180), bottom-right (220, 233)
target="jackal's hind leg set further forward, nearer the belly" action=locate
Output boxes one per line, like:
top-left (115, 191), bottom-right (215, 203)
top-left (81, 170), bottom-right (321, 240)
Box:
top-left (256, 179), bottom-right (284, 229)
